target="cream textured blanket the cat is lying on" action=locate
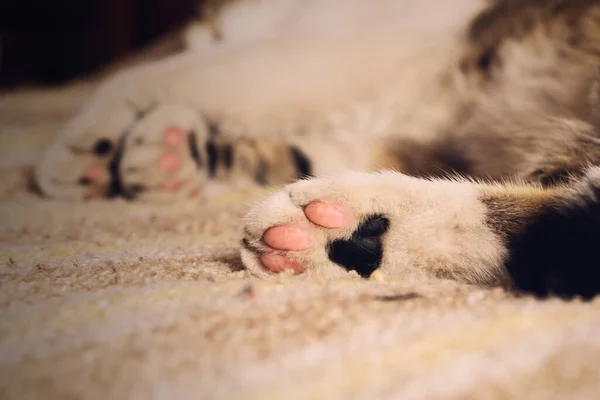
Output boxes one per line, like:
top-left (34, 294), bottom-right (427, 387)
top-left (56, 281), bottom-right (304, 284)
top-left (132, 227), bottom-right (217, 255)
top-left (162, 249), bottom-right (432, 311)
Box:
top-left (0, 89), bottom-right (600, 400)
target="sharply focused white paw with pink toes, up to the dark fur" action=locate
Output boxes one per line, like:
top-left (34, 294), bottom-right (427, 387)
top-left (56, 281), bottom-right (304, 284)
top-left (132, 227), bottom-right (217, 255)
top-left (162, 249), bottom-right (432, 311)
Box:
top-left (241, 172), bottom-right (505, 284)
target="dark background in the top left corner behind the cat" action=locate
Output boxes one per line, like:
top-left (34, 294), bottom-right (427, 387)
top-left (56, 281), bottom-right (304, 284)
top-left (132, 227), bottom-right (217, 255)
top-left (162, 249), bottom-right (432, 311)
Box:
top-left (0, 0), bottom-right (201, 88)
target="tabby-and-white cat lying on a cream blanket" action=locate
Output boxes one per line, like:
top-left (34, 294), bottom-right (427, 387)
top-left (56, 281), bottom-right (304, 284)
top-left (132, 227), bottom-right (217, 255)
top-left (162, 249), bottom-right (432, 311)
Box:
top-left (36, 0), bottom-right (600, 298)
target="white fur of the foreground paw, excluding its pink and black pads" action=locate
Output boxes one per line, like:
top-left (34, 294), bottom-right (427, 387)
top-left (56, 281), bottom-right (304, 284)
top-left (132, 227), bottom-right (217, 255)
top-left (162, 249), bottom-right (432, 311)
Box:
top-left (242, 172), bottom-right (506, 284)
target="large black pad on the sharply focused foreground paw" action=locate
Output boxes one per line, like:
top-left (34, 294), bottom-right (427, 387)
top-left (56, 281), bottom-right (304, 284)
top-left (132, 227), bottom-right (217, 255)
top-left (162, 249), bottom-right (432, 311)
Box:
top-left (328, 215), bottom-right (390, 278)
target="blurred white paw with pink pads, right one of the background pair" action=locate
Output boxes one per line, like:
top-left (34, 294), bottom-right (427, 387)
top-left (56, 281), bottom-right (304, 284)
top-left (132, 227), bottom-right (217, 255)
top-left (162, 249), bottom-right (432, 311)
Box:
top-left (115, 104), bottom-right (213, 201)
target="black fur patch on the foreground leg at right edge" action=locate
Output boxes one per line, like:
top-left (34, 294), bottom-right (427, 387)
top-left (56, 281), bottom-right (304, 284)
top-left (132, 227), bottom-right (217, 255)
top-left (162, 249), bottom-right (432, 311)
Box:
top-left (506, 169), bottom-right (600, 299)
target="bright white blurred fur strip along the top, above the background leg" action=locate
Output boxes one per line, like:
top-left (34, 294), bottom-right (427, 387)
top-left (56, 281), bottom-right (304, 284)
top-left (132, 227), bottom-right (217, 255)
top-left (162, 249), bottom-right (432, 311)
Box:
top-left (186, 0), bottom-right (485, 53)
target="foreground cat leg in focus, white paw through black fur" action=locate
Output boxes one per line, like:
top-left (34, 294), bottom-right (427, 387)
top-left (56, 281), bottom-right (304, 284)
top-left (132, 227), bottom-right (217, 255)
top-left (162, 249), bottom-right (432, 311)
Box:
top-left (241, 168), bottom-right (600, 298)
